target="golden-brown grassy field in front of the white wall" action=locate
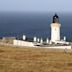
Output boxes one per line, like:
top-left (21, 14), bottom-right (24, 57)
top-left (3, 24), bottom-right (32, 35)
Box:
top-left (0, 46), bottom-right (72, 72)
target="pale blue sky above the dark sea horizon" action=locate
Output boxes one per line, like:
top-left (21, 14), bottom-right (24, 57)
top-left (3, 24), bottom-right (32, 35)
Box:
top-left (0, 0), bottom-right (72, 12)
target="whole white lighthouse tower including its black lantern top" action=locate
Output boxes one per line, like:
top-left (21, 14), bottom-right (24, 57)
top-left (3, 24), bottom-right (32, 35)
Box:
top-left (51, 14), bottom-right (61, 42)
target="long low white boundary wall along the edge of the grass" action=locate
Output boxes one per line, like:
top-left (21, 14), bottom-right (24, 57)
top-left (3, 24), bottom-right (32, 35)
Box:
top-left (13, 40), bottom-right (72, 49)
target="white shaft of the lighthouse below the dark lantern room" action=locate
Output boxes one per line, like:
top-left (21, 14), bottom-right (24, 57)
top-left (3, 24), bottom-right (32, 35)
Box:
top-left (51, 23), bottom-right (61, 42)
